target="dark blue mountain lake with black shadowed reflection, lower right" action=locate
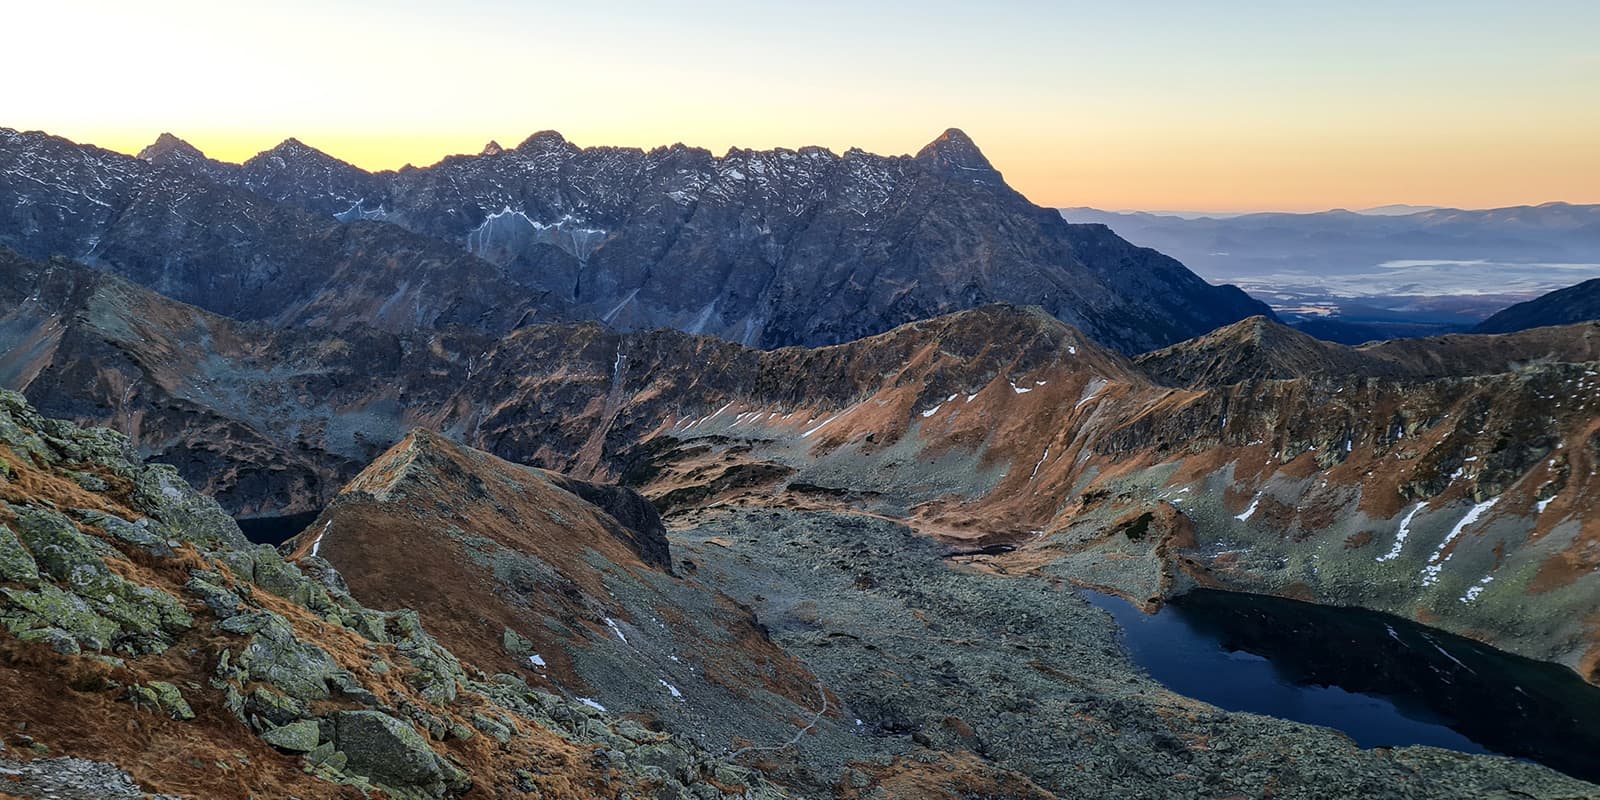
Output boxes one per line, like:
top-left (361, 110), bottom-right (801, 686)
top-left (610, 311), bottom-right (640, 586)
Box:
top-left (1083, 589), bottom-right (1600, 781)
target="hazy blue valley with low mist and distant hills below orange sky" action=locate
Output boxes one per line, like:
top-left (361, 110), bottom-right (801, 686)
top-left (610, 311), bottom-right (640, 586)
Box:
top-left (1061, 203), bottom-right (1600, 344)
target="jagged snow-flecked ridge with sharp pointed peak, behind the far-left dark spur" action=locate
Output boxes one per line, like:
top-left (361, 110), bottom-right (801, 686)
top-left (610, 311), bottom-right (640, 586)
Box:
top-left (121, 130), bottom-right (1270, 352)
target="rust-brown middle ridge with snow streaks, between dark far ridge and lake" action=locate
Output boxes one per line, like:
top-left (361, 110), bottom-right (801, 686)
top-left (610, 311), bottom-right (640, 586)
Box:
top-left (8, 252), bottom-right (1600, 691)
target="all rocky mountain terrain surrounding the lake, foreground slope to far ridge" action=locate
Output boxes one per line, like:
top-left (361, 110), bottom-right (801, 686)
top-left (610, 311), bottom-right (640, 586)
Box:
top-left (0, 130), bottom-right (1600, 800)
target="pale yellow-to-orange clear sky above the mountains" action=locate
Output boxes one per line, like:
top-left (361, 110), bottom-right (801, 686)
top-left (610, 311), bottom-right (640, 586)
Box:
top-left (12, 0), bottom-right (1600, 211)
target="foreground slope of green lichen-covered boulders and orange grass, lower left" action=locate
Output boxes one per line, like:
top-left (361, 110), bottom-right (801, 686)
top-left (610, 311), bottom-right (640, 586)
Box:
top-left (0, 392), bottom-right (781, 798)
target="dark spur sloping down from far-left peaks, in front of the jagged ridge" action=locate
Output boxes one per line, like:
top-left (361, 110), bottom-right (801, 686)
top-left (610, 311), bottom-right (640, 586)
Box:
top-left (0, 128), bottom-right (568, 331)
